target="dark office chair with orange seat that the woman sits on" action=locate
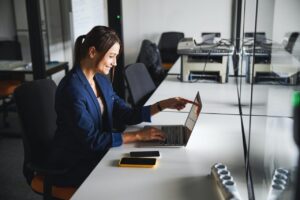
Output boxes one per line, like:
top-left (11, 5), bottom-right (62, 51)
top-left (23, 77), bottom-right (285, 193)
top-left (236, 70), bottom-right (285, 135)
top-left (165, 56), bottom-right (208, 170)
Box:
top-left (14, 79), bottom-right (76, 199)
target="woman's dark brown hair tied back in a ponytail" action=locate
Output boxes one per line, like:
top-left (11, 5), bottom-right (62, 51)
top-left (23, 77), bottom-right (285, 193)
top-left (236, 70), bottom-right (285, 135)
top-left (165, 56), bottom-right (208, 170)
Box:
top-left (74, 26), bottom-right (121, 67)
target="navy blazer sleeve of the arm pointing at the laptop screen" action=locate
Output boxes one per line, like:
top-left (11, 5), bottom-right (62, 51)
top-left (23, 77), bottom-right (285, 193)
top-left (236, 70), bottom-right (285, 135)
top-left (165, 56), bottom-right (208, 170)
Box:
top-left (112, 90), bottom-right (151, 125)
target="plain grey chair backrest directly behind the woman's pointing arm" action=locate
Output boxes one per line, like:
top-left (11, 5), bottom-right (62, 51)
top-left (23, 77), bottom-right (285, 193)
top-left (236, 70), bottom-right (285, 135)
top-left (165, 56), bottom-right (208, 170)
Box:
top-left (124, 63), bottom-right (156, 106)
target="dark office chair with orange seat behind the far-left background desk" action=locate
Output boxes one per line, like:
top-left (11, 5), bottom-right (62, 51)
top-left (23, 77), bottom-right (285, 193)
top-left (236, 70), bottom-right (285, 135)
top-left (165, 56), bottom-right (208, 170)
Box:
top-left (0, 41), bottom-right (22, 128)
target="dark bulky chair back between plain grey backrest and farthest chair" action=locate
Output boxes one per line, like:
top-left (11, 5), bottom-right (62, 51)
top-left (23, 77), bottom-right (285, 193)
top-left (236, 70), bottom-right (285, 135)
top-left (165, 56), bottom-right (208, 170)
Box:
top-left (137, 40), bottom-right (166, 86)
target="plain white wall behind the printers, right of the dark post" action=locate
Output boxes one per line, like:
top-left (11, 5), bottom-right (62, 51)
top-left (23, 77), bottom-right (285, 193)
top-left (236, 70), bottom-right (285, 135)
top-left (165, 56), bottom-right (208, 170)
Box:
top-left (122, 0), bottom-right (232, 64)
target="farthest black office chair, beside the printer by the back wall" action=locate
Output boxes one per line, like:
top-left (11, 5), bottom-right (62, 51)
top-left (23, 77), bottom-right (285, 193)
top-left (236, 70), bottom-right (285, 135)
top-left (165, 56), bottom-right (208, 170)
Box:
top-left (158, 32), bottom-right (184, 69)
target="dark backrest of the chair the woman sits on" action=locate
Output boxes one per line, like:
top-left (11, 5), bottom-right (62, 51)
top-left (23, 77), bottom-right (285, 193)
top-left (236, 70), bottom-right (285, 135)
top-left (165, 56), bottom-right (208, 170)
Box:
top-left (14, 79), bottom-right (57, 170)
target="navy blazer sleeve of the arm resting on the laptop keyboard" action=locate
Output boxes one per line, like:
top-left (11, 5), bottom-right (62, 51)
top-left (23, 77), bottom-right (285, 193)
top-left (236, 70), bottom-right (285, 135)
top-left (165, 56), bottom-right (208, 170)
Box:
top-left (68, 85), bottom-right (122, 151)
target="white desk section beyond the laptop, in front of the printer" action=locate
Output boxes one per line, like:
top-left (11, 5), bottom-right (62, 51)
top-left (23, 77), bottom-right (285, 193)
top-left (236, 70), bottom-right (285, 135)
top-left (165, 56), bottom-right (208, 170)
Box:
top-left (146, 75), bottom-right (239, 115)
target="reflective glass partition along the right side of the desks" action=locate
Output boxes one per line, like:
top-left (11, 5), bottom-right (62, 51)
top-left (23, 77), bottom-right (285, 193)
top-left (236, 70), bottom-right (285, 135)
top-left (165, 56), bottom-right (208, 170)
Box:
top-left (244, 0), bottom-right (300, 199)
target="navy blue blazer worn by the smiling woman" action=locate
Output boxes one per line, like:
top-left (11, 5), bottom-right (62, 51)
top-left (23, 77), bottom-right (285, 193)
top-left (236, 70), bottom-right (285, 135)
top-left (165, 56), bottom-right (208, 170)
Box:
top-left (50, 66), bottom-right (151, 177)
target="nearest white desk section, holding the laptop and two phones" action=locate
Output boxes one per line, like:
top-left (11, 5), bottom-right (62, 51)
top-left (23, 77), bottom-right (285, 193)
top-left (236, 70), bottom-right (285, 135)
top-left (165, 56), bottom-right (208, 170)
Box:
top-left (72, 112), bottom-right (248, 200)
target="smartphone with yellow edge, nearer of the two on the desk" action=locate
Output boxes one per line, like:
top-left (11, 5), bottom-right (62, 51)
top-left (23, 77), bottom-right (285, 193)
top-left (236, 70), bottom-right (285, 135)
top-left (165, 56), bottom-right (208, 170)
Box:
top-left (119, 157), bottom-right (156, 168)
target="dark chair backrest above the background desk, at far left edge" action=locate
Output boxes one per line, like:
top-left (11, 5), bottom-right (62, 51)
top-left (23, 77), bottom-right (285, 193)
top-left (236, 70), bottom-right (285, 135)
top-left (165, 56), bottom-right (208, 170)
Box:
top-left (0, 40), bottom-right (22, 60)
